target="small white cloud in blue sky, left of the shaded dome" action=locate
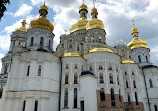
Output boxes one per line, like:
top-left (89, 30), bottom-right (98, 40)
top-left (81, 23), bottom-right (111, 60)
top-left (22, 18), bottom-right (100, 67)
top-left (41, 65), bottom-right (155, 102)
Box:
top-left (14, 4), bottom-right (33, 17)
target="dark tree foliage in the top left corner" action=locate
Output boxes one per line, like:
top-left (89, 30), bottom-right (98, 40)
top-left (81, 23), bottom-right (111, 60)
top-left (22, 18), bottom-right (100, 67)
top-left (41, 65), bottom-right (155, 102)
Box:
top-left (0, 0), bottom-right (10, 20)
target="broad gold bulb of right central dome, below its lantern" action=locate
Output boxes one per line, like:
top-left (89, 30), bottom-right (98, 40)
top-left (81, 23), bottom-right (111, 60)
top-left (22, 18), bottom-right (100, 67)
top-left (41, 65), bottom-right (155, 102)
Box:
top-left (86, 19), bottom-right (104, 30)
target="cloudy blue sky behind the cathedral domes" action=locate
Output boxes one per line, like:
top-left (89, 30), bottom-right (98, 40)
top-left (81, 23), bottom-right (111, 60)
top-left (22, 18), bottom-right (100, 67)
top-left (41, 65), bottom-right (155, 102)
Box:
top-left (0, 0), bottom-right (158, 71)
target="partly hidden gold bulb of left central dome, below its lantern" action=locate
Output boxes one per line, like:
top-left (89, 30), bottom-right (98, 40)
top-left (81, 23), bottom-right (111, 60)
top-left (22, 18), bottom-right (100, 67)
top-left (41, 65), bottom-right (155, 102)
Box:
top-left (70, 20), bottom-right (88, 33)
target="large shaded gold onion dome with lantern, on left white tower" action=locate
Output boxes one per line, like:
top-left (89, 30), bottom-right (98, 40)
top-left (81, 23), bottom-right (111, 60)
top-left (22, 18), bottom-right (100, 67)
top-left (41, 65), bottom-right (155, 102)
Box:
top-left (29, 3), bottom-right (54, 32)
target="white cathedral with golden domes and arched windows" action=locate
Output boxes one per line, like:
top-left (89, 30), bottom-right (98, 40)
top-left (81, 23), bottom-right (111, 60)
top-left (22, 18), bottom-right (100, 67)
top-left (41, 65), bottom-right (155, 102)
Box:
top-left (0, 3), bottom-right (158, 111)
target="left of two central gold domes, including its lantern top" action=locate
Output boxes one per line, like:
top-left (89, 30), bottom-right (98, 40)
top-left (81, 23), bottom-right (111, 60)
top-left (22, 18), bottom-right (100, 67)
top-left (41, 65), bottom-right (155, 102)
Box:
top-left (70, 3), bottom-right (88, 33)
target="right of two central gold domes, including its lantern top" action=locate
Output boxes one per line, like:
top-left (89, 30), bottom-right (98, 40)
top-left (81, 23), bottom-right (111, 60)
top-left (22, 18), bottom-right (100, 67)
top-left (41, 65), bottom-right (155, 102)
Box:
top-left (86, 7), bottom-right (104, 30)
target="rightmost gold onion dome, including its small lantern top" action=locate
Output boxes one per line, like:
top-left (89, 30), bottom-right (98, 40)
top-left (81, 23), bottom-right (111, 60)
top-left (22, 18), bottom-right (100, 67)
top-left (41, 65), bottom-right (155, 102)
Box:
top-left (127, 25), bottom-right (147, 49)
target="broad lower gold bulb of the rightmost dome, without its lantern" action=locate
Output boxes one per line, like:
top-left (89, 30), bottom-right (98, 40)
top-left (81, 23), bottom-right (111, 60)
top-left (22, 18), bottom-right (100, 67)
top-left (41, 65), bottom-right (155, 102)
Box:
top-left (127, 37), bottom-right (147, 49)
